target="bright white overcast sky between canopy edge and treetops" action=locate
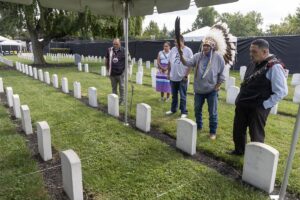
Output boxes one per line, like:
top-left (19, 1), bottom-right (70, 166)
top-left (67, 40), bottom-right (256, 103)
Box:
top-left (143, 0), bottom-right (300, 32)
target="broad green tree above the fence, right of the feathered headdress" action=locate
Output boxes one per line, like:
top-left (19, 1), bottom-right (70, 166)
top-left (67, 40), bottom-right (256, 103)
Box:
top-left (218, 11), bottom-right (263, 37)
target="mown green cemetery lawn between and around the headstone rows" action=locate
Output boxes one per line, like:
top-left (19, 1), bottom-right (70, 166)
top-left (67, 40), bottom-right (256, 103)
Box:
top-left (0, 57), bottom-right (300, 199)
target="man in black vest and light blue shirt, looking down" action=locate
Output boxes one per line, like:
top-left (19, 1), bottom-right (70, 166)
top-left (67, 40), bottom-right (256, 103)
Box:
top-left (230, 39), bottom-right (288, 155)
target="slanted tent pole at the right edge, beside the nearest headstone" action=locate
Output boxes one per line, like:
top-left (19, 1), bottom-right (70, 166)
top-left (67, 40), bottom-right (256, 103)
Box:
top-left (279, 105), bottom-right (300, 200)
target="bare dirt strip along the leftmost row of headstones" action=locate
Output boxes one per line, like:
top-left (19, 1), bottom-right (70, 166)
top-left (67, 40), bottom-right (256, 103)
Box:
top-left (0, 93), bottom-right (93, 200)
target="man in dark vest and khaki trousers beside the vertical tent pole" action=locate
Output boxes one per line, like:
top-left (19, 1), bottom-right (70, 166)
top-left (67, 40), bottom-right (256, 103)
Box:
top-left (105, 38), bottom-right (125, 105)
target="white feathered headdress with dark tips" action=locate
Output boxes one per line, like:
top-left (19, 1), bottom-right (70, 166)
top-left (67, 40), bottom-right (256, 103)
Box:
top-left (202, 23), bottom-right (235, 65)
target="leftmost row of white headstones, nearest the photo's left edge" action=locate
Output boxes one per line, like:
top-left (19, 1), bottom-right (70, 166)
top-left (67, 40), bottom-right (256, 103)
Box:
top-left (0, 78), bottom-right (83, 200)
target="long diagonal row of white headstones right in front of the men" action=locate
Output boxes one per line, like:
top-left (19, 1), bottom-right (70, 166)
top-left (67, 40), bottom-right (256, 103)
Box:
top-left (5, 59), bottom-right (279, 199)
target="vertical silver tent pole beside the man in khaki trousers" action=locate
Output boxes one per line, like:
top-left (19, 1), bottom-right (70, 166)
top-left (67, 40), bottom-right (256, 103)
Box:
top-left (123, 1), bottom-right (129, 125)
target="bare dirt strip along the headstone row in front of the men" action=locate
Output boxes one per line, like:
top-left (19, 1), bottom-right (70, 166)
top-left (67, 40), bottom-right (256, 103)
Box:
top-left (1, 66), bottom-right (299, 200)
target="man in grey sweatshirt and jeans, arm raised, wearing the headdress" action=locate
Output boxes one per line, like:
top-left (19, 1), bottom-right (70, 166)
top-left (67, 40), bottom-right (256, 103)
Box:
top-left (181, 38), bottom-right (225, 140)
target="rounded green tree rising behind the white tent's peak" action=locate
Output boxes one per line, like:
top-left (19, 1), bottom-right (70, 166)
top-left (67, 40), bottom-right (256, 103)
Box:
top-left (192, 7), bottom-right (219, 30)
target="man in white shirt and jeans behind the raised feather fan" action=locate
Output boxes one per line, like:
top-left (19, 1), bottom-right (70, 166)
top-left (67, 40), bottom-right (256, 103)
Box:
top-left (166, 35), bottom-right (193, 118)
